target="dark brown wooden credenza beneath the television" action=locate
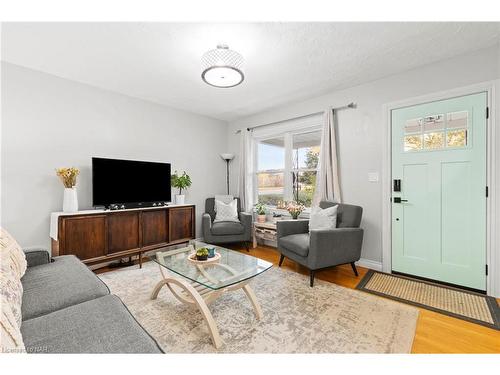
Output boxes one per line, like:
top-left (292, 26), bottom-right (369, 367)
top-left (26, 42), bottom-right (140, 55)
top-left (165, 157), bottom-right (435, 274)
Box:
top-left (52, 205), bottom-right (195, 266)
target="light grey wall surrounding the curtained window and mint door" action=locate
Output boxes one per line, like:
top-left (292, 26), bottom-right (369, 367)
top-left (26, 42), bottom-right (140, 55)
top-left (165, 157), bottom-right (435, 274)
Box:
top-left (228, 46), bottom-right (500, 262)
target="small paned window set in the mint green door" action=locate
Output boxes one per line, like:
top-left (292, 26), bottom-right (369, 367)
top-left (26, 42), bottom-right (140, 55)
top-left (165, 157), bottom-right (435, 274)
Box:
top-left (403, 111), bottom-right (469, 152)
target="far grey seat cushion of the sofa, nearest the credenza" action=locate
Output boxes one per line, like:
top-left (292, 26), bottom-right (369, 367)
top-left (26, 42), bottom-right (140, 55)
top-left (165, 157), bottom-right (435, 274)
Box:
top-left (21, 255), bottom-right (109, 321)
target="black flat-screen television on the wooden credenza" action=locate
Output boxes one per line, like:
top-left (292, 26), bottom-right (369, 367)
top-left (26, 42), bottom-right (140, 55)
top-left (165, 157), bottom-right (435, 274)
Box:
top-left (92, 158), bottom-right (171, 206)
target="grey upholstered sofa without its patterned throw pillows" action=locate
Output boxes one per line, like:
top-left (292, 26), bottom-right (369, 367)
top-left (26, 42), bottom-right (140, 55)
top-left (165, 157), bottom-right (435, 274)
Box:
top-left (21, 249), bottom-right (163, 353)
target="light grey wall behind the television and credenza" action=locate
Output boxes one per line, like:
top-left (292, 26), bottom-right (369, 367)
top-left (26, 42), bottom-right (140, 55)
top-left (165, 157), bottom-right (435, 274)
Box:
top-left (1, 62), bottom-right (227, 251)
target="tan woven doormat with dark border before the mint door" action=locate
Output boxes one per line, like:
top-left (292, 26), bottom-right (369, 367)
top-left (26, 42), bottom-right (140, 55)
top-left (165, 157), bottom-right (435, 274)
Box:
top-left (356, 270), bottom-right (500, 330)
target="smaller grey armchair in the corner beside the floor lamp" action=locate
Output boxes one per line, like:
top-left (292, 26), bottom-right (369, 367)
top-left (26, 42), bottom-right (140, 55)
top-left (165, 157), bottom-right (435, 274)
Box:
top-left (201, 198), bottom-right (252, 251)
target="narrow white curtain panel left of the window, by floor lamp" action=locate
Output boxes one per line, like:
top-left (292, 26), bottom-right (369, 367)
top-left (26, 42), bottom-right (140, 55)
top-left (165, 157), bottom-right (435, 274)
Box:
top-left (238, 129), bottom-right (254, 212)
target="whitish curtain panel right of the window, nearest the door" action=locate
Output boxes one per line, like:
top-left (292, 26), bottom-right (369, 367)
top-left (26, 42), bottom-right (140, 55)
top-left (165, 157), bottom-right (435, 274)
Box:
top-left (313, 109), bottom-right (342, 206)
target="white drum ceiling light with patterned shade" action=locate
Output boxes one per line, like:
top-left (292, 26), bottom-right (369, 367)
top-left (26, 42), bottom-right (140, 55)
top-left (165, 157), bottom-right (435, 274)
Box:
top-left (201, 44), bottom-right (245, 88)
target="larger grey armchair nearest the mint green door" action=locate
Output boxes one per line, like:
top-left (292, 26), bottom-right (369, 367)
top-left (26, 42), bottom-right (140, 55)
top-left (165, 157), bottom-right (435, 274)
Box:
top-left (277, 201), bottom-right (363, 287)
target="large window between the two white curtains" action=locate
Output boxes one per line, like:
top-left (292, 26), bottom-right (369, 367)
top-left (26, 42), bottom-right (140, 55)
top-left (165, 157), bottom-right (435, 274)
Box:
top-left (256, 126), bottom-right (321, 207)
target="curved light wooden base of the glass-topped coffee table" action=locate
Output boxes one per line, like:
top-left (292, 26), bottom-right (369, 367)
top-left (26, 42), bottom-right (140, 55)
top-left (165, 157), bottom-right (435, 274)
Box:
top-left (151, 263), bottom-right (262, 349)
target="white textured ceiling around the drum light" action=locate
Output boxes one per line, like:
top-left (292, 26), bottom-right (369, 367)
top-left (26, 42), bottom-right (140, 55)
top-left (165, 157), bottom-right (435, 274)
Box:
top-left (2, 22), bottom-right (500, 121)
